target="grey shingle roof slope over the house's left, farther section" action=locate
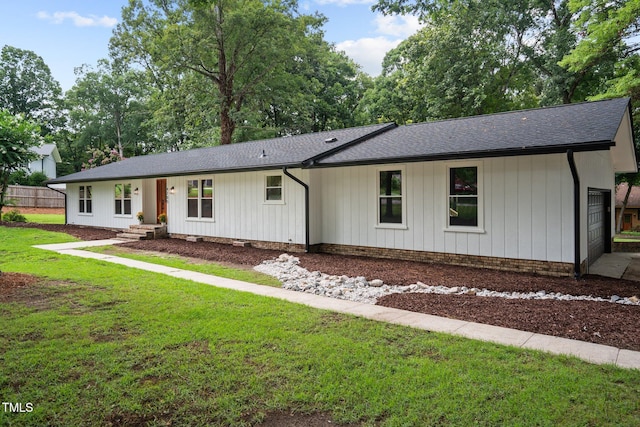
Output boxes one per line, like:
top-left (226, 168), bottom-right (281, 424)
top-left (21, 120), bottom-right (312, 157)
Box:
top-left (49, 123), bottom-right (396, 183)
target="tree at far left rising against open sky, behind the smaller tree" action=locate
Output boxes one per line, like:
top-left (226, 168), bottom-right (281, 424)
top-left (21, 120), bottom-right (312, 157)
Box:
top-left (0, 45), bottom-right (64, 134)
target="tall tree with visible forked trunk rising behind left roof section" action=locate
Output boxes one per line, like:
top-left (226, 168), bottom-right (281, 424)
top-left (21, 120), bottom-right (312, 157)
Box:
top-left (112, 0), bottom-right (317, 144)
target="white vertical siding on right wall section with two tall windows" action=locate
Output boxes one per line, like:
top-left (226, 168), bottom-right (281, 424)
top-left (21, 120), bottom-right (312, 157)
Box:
top-left (312, 153), bottom-right (580, 262)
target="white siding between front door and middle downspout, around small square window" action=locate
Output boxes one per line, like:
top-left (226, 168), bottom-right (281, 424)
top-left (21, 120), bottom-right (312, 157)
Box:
top-left (167, 169), bottom-right (309, 244)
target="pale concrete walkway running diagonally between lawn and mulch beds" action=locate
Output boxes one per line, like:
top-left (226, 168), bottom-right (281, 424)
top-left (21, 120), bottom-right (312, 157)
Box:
top-left (35, 240), bottom-right (640, 369)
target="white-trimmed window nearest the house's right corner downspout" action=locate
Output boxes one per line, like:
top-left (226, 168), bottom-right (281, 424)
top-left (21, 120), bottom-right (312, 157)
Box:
top-left (447, 166), bottom-right (481, 228)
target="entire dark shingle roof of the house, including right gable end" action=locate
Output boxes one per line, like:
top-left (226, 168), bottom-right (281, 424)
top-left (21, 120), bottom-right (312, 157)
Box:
top-left (49, 98), bottom-right (637, 183)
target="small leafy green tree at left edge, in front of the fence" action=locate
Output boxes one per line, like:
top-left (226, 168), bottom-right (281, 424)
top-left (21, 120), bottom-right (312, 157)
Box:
top-left (0, 110), bottom-right (41, 217)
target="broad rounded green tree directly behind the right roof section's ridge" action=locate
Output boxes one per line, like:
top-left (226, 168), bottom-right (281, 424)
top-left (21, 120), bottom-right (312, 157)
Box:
top-left (368, 1), bottom-right (537, 122)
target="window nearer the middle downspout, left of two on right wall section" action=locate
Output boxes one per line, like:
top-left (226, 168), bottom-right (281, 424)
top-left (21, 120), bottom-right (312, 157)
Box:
top-left (378, 168), bottom-right (405, 225)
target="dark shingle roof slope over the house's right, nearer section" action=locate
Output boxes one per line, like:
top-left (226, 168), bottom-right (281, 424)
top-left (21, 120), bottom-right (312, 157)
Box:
top-left (317, 98), bottom-right (629, 166)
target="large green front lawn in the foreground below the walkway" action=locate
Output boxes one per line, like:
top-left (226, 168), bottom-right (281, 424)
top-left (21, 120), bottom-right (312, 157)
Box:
top-left (0, 227), bottom-right (640, 426)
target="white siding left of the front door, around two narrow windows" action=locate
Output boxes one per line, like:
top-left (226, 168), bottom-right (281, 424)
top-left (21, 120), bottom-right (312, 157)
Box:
top-left (67, 179), bottom-right (143, 229)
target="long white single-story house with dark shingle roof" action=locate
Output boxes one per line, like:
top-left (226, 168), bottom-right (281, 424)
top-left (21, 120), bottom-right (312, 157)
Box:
top-left (48, 99), bottom-right (637, 276)
